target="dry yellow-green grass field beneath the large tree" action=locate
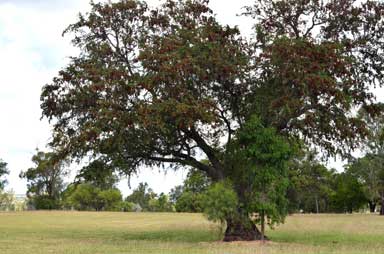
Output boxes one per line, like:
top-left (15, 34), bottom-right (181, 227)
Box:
top-left (0, 212), bottom-right (384, 254)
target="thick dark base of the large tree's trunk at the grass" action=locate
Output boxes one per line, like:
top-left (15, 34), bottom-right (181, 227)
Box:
top-left (224, 213), bottom-right (268, 242)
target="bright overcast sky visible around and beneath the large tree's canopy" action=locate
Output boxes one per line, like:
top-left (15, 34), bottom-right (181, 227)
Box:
top-left (0, 0), bottom-right (252, 195)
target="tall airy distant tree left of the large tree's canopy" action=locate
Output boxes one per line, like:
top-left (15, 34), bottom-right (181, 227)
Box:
top-left (20, 151), bottom-right (68, 209)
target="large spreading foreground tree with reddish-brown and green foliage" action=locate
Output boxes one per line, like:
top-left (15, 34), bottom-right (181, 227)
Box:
top-left (41, 0), bottom-right (384, 240)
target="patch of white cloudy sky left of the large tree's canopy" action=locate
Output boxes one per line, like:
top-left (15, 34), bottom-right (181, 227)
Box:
top-left (0, 1), bottom-right (87, 193)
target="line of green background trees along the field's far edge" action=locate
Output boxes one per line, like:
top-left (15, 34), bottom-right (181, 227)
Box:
top-left (18, 142), bottom-right (384, 216)
